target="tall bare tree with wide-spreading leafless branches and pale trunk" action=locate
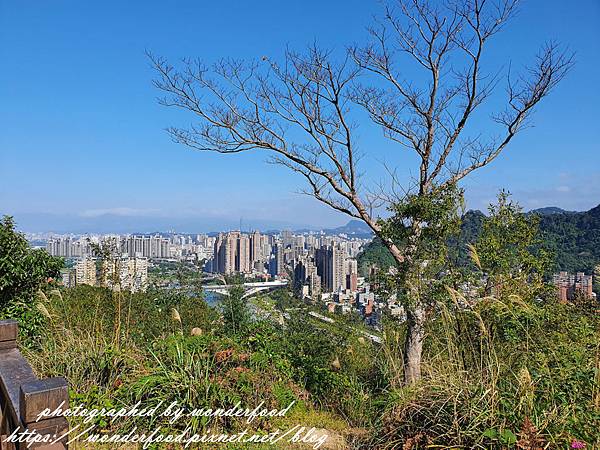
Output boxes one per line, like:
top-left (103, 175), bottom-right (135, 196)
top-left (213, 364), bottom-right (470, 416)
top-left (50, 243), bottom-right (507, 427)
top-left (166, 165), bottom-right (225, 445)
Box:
top-left (149, 0), bottom-right (573, 383)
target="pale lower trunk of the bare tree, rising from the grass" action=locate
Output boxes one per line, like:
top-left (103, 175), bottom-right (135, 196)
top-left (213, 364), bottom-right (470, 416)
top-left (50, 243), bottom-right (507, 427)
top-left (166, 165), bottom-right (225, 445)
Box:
top-left (404, 305), bottom-right (425, 384)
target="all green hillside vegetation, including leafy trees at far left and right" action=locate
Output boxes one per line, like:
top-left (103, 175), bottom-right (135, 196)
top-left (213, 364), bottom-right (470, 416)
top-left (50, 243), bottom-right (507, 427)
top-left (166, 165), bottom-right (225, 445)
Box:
top-left (0, 202), bottom-right (600, 450)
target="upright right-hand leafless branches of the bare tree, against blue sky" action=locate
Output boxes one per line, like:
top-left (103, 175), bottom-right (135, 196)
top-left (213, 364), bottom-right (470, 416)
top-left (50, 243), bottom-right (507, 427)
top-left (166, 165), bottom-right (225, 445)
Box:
top-left (350, 0), bottom-right (572, 192)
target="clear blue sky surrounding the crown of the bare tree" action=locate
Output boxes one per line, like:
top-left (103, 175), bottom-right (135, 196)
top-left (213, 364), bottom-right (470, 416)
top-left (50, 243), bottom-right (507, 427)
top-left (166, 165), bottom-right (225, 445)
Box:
top-left (0, 0), bottom-right (600, 231)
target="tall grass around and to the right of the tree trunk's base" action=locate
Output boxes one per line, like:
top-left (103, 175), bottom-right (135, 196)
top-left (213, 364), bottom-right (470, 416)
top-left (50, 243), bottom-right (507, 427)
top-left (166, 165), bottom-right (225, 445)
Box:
top-left (371, 293), bottom-right (600, 449)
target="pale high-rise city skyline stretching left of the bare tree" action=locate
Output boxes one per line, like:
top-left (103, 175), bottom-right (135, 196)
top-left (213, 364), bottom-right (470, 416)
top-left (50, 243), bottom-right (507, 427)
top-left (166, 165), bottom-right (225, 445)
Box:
top-left (46, 231), bottom-right (373, 315)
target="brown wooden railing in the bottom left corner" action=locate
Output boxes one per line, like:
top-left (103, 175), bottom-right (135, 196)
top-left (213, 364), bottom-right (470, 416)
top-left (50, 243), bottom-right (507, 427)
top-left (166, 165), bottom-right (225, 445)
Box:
top-left (0, 320), bottom-right (69, 450)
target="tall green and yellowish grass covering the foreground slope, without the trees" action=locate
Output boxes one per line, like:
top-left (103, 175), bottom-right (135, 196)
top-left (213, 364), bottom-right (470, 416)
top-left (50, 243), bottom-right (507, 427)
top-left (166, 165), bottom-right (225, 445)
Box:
top-left (24, 288), bottom-right (600, 450)
